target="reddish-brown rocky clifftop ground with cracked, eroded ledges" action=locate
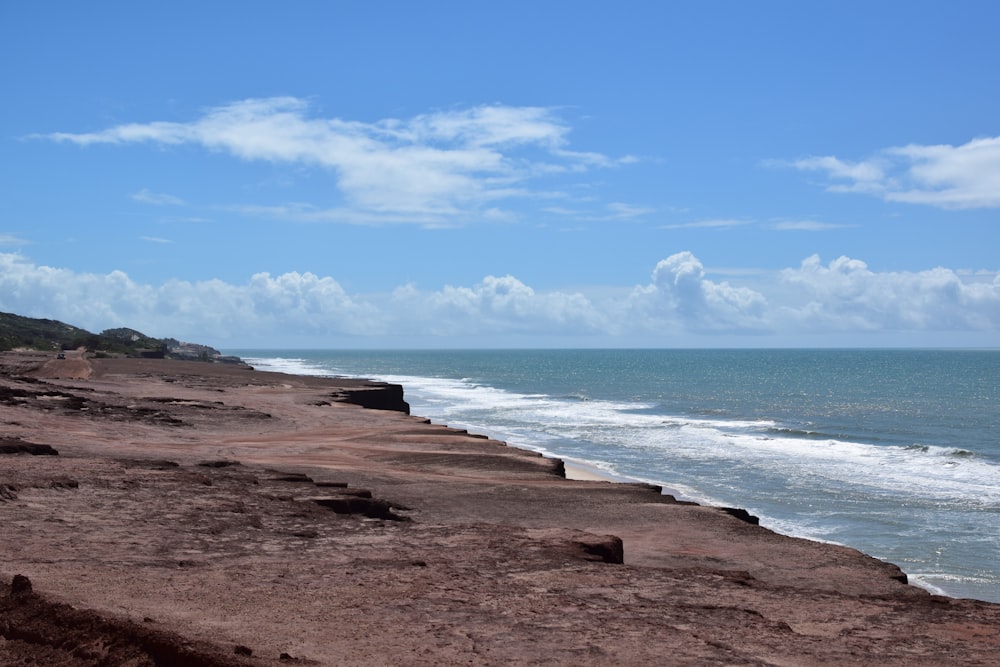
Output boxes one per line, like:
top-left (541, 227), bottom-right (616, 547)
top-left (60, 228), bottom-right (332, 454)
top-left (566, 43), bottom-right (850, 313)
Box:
top-left (0, 353), bottom-right (1000, 666)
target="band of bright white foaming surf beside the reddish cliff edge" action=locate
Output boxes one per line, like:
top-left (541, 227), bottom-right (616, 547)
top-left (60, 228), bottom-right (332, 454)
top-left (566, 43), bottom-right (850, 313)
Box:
top-left (248, 358), bottom-right (1000, 504)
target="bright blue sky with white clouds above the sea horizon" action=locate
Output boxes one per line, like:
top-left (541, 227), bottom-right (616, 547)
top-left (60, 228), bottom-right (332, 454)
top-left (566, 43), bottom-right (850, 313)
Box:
top-left (0, 0), bottom-right (1000, 350)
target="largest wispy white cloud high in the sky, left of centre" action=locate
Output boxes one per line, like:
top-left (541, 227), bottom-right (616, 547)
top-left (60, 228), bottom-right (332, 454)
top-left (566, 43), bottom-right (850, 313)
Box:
top-left (38, 97), bottom-right (629, 224)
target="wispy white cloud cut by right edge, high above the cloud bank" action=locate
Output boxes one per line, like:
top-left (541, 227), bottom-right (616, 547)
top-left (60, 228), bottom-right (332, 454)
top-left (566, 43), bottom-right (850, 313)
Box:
top-left (791, 137), bottom-right (1000, 209)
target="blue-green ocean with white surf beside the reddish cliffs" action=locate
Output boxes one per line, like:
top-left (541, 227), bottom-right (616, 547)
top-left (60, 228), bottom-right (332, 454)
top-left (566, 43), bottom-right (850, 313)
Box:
top-left (230, 350), bottom-right (1000, 603)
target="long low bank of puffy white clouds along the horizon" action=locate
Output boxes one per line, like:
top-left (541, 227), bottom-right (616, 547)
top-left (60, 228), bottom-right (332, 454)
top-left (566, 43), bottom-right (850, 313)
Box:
top-left (0, 252), bottom-right (1000, 346)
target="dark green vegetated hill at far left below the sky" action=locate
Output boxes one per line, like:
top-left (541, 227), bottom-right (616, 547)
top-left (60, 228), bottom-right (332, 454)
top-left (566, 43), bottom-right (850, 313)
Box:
top-left (0, 313), bottom-right (239, 362)
